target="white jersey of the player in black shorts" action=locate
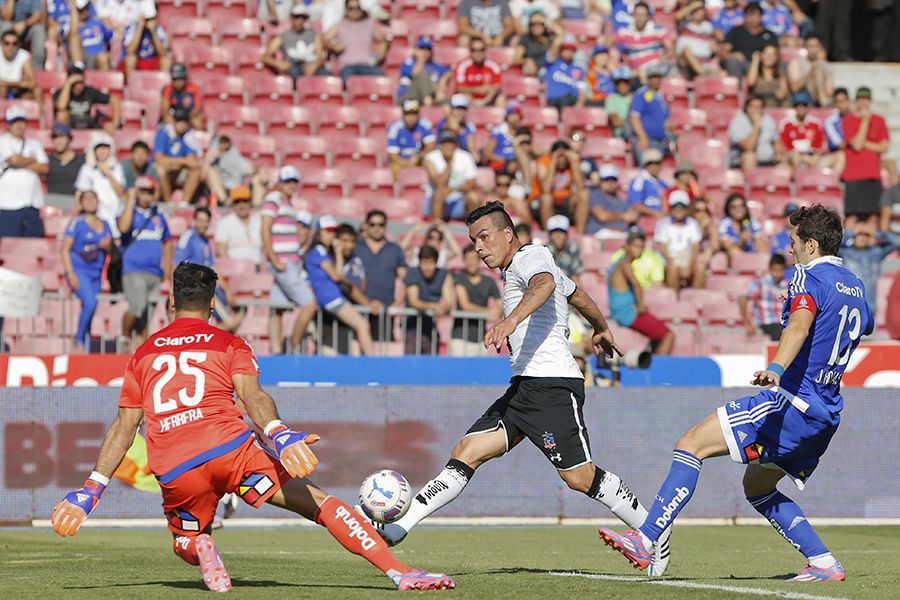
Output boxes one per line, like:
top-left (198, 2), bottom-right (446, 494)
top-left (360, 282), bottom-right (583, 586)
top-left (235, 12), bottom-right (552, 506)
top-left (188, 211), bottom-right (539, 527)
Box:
top-left (502, 244), bottom-right (583, 378)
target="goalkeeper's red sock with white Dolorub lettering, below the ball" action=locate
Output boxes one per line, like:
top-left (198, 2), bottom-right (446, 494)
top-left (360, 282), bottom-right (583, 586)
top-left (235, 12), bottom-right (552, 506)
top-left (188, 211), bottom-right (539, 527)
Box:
top-left (316, 496), bottom-right (410, 577)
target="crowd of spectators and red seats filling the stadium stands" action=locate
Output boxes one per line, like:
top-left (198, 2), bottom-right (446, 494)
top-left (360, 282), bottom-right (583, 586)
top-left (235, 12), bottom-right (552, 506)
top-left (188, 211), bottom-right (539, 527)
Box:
top-left (0, 0), bottom-right (900, 355)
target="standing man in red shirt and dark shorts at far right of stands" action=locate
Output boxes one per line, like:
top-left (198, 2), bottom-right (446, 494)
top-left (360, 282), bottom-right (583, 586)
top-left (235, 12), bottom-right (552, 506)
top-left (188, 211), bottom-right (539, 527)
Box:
top-left (841, 87), bottom-right (889, 218)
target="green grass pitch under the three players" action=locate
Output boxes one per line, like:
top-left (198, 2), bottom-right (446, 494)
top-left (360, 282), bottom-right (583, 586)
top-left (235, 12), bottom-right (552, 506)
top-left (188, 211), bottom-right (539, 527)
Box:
top-left (0, 526), bottom-right (900, 600)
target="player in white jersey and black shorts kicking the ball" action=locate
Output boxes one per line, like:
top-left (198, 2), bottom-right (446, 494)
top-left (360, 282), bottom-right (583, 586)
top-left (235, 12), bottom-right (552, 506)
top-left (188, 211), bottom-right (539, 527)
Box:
top-left (379, 202), bottom-right (669, 575)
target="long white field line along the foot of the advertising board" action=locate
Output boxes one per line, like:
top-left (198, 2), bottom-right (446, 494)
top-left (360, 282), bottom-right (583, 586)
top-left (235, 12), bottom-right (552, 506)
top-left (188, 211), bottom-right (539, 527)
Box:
top-left (31, 517), bottom-right (900, 529)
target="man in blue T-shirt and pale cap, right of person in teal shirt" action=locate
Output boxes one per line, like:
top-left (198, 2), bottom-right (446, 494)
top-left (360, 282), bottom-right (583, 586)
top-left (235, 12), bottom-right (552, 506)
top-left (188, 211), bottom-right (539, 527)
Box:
top-left (628, 65), bottom-right (675, 164)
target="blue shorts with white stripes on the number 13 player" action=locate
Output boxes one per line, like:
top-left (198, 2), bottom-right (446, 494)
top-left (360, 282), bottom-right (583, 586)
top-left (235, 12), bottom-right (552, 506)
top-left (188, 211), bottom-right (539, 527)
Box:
top-left (717, 386), bottom-right (837, 489)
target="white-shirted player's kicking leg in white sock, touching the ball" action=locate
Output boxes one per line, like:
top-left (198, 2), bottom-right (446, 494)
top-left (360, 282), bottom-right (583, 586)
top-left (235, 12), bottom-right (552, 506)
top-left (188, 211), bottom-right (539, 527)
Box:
top-left (378, 426), bottom-right (507, 546)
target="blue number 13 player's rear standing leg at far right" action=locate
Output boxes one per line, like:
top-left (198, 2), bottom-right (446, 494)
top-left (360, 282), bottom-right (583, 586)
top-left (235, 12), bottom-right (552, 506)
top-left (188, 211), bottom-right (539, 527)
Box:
top-left (744, 465), bottom-right (847, 581)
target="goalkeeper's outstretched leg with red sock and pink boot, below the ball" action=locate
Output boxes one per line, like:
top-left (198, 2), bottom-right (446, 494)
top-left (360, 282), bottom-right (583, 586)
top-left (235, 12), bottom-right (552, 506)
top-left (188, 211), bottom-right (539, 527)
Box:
top-left (268, 479), bottom-right (456, 590)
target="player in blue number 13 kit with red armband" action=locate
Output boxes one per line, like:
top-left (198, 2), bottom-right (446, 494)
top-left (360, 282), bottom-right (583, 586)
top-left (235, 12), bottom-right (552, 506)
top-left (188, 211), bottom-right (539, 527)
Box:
top-left (600, 205), bottom-right (875, 581)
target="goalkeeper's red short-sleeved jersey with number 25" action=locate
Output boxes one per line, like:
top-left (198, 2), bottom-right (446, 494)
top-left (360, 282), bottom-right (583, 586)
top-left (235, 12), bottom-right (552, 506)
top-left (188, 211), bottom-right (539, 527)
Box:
top-left (119, 318), bottom-right (259, 483)
